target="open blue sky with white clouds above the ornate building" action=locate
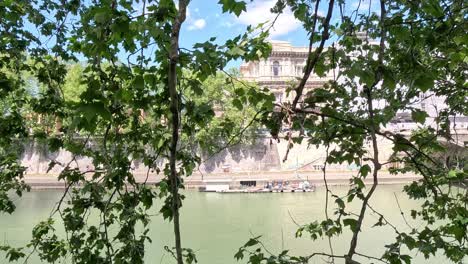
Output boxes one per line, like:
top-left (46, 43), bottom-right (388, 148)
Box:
top-left (180, 0), bottom-right (377, 68)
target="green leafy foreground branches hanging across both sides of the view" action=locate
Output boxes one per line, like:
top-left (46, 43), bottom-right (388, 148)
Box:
top-left (0, 0), bottom-right (468, 264)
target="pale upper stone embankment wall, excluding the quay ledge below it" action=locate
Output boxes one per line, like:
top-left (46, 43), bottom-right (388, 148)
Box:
top-left (18, 138), bottom-right (398, 175)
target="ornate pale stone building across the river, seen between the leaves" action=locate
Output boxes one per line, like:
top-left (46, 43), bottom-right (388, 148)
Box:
top-left (240, 41), bottom-right (468, 132)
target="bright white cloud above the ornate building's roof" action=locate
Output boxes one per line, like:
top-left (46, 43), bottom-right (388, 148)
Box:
top-left (236, 0), bottom-right (301, 37)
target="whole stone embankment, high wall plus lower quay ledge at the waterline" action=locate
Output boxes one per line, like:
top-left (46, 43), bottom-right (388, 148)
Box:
top-left (15, 138), bottom-right (428, 188)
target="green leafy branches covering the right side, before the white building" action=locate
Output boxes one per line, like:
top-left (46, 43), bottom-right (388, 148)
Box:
top-left (236, 0), bottom-right (468, 264)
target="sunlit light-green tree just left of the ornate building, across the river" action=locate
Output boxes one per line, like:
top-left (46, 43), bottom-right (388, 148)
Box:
top-left (189, 71), bottom-right (273, 156)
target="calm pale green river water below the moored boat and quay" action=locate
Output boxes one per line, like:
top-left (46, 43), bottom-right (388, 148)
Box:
top-left (0, 185), bottom-right (450, 264)
